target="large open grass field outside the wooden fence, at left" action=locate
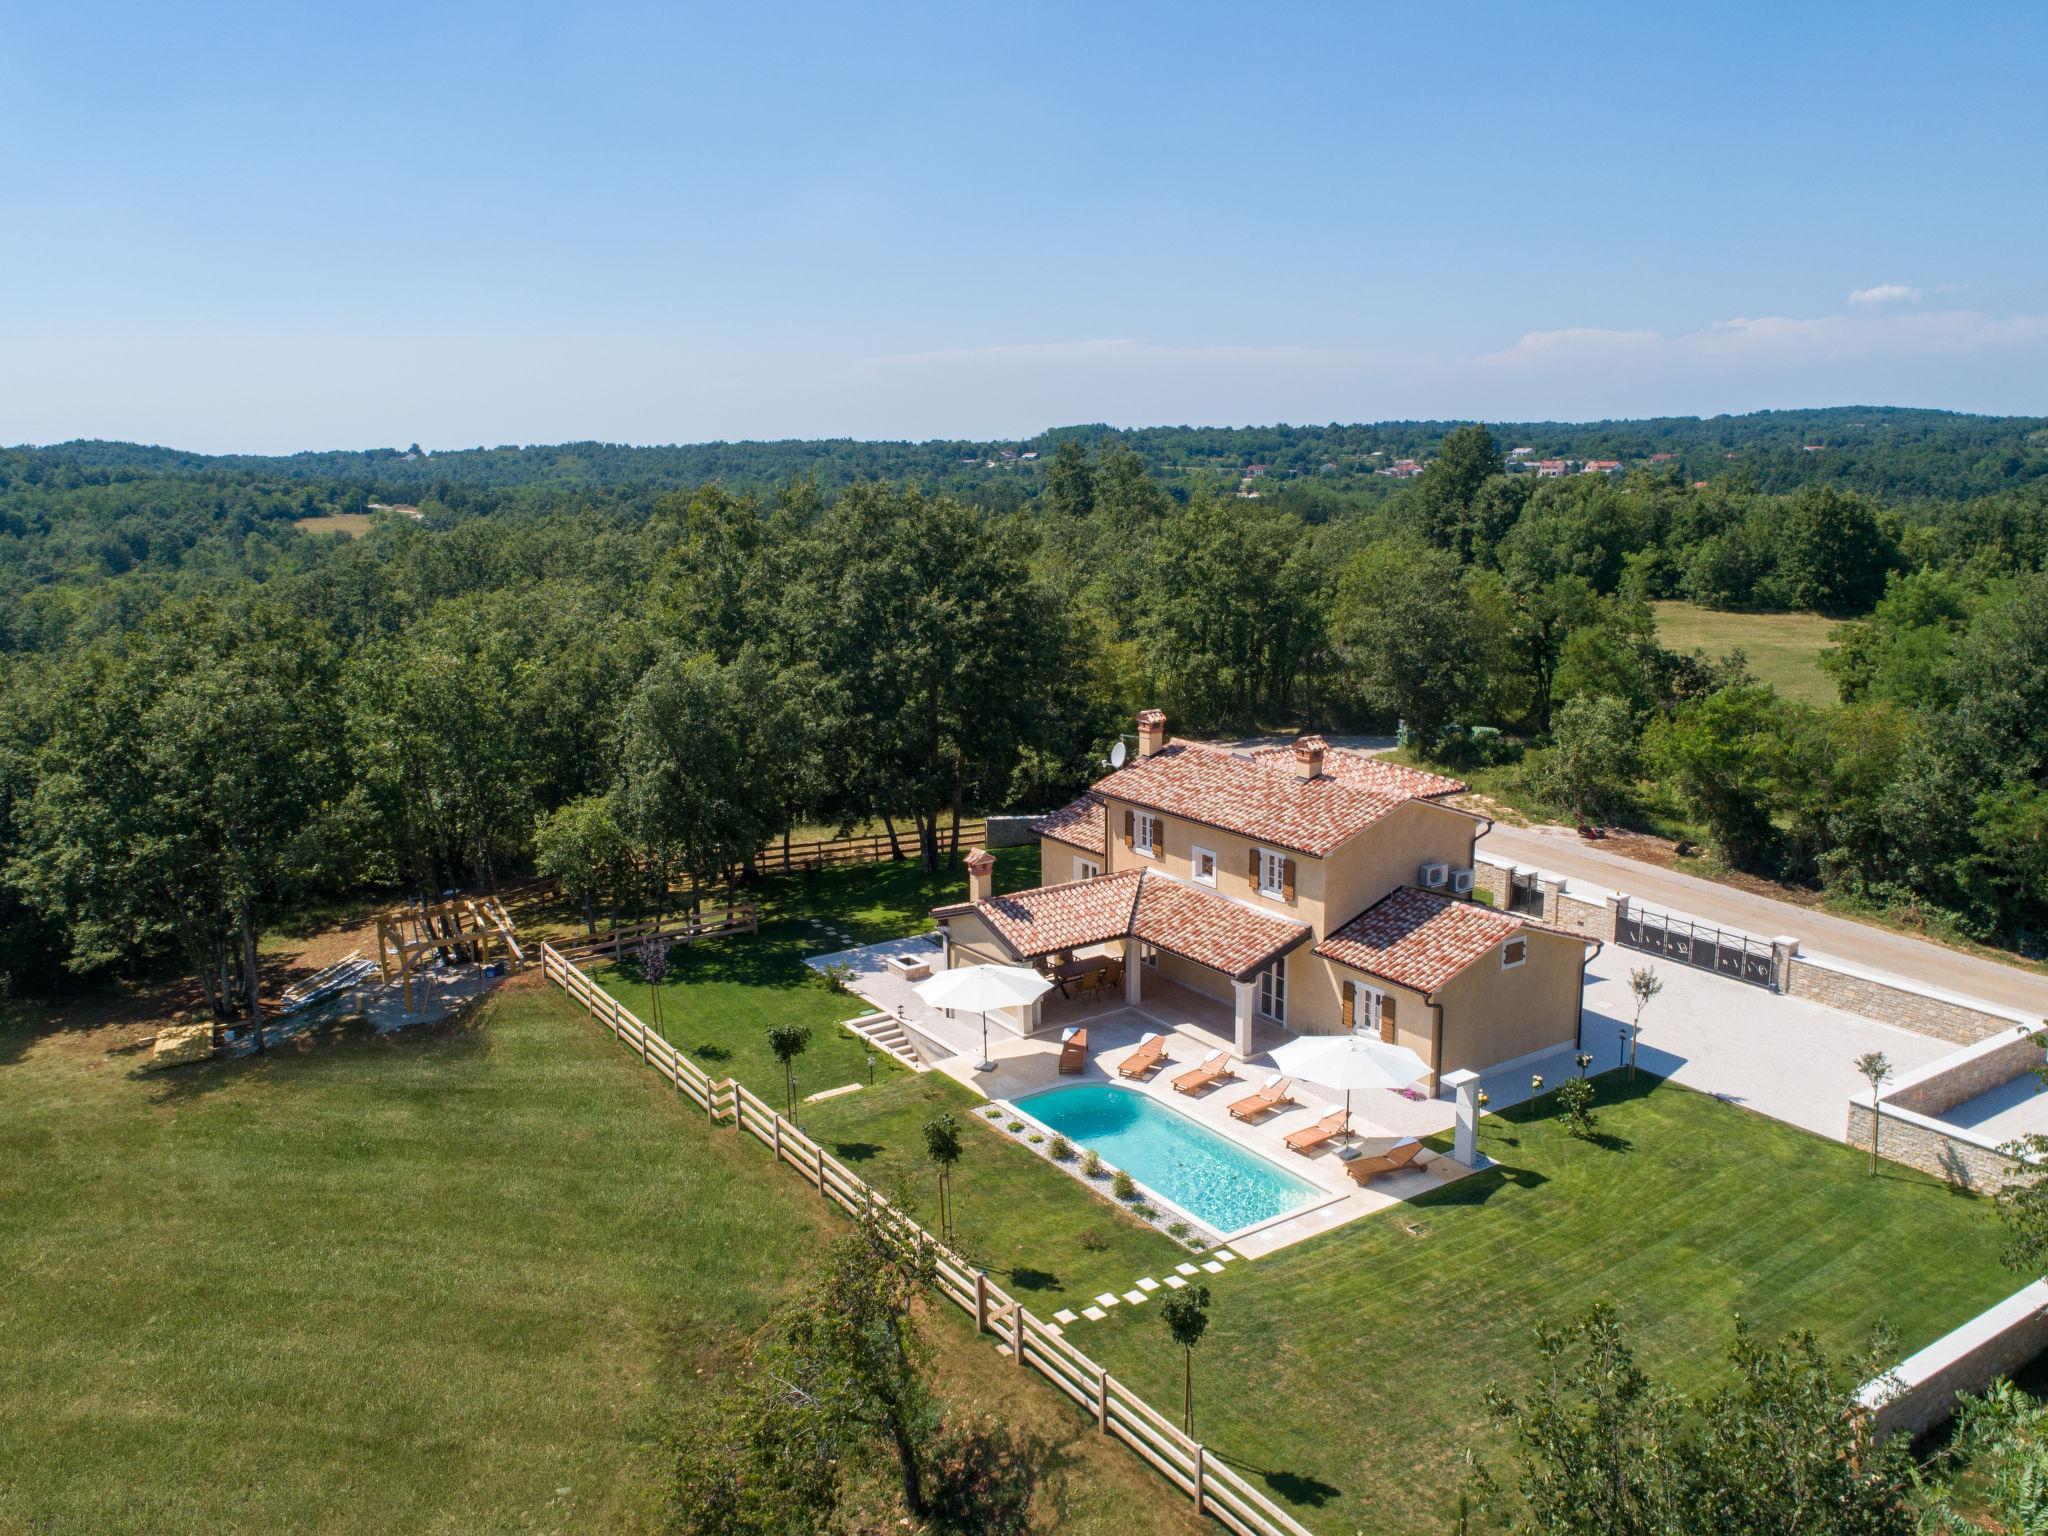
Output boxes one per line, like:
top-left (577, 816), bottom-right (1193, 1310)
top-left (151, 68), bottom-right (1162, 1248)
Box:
top-left (0, 981), bottom-right (1194, 1534)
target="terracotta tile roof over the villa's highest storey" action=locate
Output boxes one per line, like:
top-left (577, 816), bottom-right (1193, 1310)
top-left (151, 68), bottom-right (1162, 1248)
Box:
top-left (1096, 741), bottom-right (1464, 858)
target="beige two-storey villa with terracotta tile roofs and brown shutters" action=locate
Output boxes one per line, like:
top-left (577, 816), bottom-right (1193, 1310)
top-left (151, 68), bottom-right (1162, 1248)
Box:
top-left (932, 709), bottom-right (1599, 1094)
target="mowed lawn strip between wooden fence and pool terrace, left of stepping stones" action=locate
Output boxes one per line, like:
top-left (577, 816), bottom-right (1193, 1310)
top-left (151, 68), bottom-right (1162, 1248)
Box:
top-left (592, 848), bottom-right (1186, 1318)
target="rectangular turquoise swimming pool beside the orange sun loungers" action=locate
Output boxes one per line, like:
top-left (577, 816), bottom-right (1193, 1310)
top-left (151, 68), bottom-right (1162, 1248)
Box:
top-left (1018, 1083), bottom-right (1323, 1233)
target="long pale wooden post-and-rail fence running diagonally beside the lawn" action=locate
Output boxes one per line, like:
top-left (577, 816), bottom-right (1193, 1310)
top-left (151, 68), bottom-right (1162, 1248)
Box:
top-left (541, 944), bottom-right (1313, 1536)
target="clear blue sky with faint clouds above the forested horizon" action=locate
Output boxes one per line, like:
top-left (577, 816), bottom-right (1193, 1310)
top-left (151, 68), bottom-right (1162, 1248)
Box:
top-left (0, 2), bottom-right (2048, 451)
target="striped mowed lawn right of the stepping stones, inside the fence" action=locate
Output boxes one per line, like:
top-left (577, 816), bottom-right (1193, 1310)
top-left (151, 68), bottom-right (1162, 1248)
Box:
top-left (1085, 1075), bottom-right (2023, 1536)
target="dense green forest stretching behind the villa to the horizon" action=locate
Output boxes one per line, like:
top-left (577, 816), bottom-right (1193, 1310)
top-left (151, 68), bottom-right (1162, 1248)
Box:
top-left (0, 410), bottom-right (2048, 1016)
